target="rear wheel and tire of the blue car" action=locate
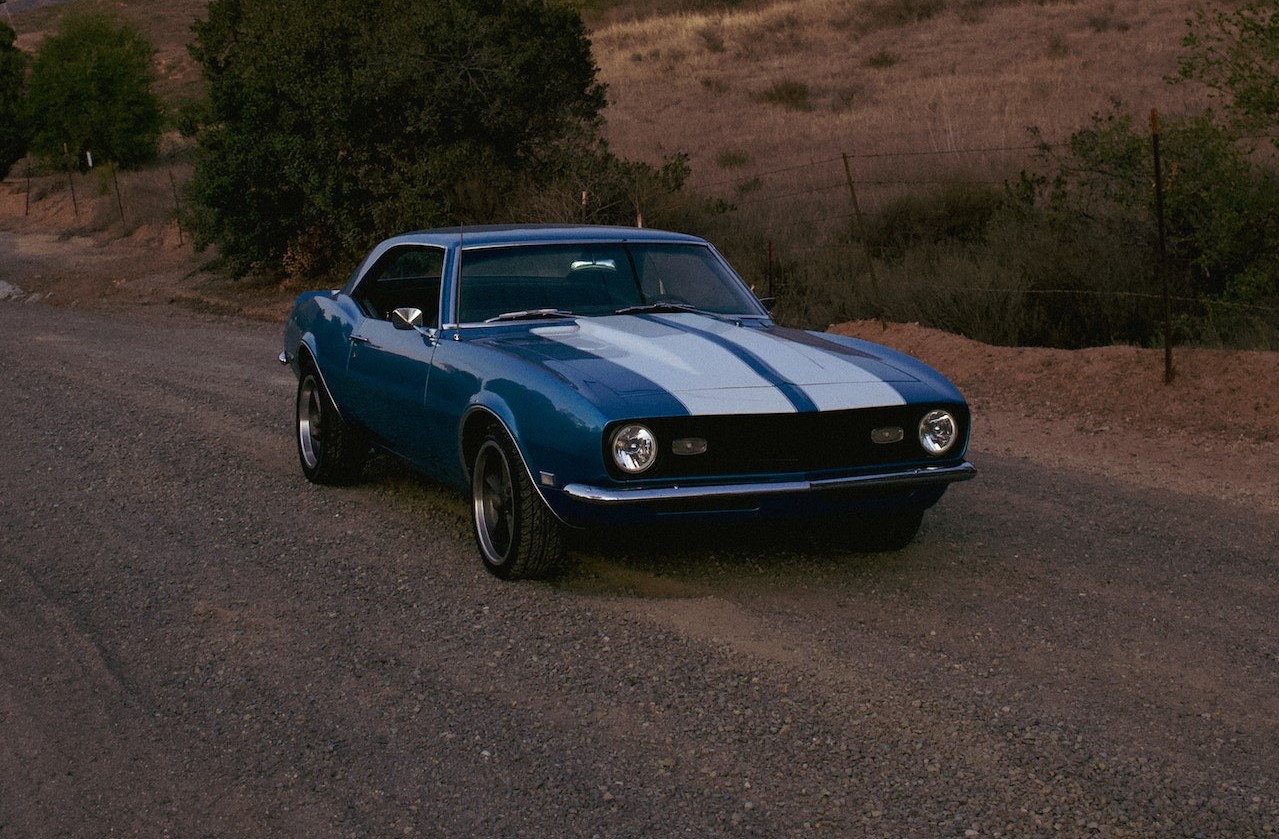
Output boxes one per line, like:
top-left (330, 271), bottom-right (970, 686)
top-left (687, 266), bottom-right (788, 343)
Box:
top-left (297, 367), bottom-right (368, 485)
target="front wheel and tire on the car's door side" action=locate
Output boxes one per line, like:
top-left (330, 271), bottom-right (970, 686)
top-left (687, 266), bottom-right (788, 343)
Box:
top-left (471, 426), bottom-right (564, 579)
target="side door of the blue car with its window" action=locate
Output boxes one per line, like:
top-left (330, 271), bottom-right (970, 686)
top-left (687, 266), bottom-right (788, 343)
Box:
top-left (347, 246), bottom-right (444, 471)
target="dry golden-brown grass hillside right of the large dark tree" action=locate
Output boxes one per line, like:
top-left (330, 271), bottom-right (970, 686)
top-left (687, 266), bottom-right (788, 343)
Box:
top-left (592, 0), bottom-right (1202, 184)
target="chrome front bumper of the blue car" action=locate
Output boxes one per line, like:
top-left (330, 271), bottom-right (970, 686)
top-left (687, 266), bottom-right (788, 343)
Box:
top-left (564, 462), bottom-right (977, 504)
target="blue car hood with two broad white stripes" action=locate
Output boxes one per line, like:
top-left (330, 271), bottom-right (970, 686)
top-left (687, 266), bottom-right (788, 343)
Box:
top-left (475, 313), bottom-right (958, 414)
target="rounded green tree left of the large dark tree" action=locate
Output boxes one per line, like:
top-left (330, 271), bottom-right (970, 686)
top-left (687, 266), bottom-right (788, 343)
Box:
top-left (26, 12), bottom-right (162, 166)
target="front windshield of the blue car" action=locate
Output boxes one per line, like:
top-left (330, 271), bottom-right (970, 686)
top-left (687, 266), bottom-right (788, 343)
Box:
top-left (458, 243), bottom-right (760, 324)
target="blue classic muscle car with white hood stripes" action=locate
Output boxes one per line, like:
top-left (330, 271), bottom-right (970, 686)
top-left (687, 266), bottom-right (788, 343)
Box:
top-left (280, 225), bottom-right (976, 578)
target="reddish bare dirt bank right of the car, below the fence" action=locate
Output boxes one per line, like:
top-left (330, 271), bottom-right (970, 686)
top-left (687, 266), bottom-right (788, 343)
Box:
top-left (831, 321), bottom-right (1279, 509)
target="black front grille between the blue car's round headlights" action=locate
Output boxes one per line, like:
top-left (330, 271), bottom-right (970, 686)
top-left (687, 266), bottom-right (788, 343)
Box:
top-left (605, 404), bottom-right (968, 480)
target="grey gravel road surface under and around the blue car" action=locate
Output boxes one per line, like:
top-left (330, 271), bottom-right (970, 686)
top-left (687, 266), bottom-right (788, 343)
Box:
top-left (0, 302), bottom-right (1279, 839)
